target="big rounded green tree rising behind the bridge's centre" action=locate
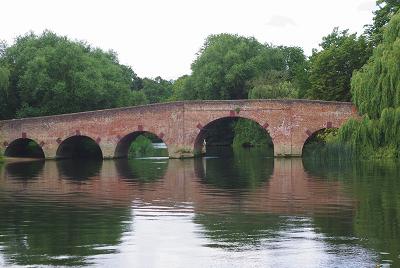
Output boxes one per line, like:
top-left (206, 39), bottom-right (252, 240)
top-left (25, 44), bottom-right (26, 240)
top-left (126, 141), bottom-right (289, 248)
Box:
top-left (183, 34), bottom-right (285, 99)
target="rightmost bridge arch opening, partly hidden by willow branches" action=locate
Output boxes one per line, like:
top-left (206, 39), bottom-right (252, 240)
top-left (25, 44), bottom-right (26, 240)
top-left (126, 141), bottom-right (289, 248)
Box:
top-left (301, 127), bottom-right (338, 157)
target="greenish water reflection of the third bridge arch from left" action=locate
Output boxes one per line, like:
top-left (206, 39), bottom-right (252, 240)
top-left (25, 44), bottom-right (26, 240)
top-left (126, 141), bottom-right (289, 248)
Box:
top-left (115, 158), bottom-right (168, 182)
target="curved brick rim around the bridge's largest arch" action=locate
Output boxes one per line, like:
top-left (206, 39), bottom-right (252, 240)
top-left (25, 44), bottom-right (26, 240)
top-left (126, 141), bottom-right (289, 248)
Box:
top-left (194, 116), bottom-right (274, 155)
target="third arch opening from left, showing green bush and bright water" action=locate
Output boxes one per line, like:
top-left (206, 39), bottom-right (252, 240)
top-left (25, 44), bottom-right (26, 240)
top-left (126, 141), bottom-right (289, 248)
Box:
top-left (114, 131), bottom-right (168, 158)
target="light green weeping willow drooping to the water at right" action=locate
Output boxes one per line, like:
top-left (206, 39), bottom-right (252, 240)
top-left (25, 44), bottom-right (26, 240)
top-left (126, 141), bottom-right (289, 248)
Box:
top-left (310, 12), bottom-right (400, 159)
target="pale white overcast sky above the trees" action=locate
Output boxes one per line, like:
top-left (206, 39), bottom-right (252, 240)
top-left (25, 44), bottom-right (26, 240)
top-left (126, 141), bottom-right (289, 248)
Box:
top-left (0, 0), bottom-right (375, 79)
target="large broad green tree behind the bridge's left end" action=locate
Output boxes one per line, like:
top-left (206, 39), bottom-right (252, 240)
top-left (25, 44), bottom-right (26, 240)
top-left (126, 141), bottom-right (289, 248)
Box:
top-left (0, 31), bottom-right (147, 118)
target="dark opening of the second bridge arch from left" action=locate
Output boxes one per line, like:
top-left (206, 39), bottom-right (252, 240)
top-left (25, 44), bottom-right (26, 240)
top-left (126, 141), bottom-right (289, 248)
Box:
top-left (56, 135), bottom-right (103, 159)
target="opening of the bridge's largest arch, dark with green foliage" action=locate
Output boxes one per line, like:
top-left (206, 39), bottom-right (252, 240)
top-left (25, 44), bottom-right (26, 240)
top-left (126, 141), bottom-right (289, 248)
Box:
top-left (194, 117), bottom-right (274, 156)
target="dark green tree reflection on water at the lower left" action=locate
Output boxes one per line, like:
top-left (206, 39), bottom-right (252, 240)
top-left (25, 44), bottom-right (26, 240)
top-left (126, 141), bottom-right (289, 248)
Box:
top-left (0, 201), bottom-right (132, 266)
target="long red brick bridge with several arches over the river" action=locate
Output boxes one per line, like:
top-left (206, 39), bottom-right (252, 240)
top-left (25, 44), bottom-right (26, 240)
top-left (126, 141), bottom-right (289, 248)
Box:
top-left (0, 100), bottom-right (358, 158)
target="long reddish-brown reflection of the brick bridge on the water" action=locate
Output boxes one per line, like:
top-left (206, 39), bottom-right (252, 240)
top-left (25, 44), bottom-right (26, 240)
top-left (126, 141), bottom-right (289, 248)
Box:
top-left (0, 158), bottom-right (354, 215)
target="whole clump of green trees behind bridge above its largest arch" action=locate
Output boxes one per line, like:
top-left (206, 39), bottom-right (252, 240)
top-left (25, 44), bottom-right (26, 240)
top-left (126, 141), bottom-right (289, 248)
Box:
top-left (175, 34), bottom-right (306, 100)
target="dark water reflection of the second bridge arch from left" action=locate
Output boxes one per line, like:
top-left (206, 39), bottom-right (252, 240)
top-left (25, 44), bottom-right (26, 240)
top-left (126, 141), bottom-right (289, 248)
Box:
top-left (57, 159), bottom-right (103, 180)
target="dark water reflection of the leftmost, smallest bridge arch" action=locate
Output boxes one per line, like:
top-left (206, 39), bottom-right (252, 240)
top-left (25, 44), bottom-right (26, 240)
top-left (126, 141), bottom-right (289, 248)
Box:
top-left (4, 160), bottom-right (44, 180)
